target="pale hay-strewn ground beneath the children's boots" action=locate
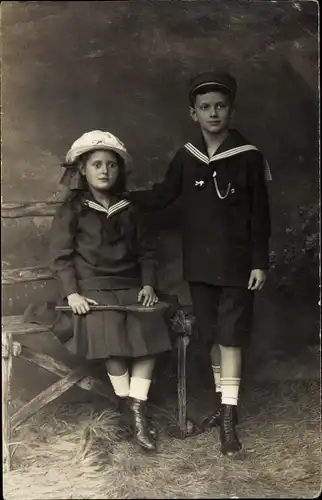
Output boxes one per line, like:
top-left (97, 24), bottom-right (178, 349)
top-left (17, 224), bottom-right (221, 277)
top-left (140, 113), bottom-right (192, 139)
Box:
top-left (4, 381), bottom-right (321, 500)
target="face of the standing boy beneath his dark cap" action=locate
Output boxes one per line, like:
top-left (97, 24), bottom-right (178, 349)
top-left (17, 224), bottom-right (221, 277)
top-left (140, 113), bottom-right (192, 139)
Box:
top-left (190, 91), bottom-right (233, 134)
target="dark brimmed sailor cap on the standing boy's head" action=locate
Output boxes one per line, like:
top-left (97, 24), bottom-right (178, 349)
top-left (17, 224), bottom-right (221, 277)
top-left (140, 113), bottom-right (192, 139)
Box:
top-left (189, 71), bottom-right (237, 100)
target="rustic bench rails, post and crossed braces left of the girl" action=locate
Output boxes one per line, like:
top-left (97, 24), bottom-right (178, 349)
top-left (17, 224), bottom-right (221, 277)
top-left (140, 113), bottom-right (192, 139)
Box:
top-left (1, 202), bottom-right (116, 471)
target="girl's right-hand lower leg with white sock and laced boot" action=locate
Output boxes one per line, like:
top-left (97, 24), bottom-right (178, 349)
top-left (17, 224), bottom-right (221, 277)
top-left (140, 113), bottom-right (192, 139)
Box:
top-left (129, 356), bottom-right (156, 451)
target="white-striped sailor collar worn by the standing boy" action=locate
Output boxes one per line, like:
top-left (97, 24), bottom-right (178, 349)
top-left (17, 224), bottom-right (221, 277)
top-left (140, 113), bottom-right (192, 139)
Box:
top-left (184, 130), bottom-right (272, 181)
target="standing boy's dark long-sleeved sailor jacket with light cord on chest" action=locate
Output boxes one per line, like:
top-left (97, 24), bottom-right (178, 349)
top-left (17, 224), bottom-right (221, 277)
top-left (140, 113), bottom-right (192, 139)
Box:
top-left (125, 130), bottom-right (271, 287)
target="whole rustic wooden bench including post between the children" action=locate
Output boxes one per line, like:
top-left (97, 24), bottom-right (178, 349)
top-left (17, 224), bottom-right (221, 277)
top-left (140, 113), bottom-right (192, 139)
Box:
top-left (1, 202), bottom-right (193, 471)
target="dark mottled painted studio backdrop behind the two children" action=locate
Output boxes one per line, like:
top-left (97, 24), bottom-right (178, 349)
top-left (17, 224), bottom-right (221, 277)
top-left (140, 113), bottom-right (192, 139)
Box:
top-left (2, 0), bottom-right (319, 397)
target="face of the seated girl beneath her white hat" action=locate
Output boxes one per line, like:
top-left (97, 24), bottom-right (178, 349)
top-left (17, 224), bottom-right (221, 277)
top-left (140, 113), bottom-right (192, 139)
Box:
top-left (80, 149), bottom-right (119, 191)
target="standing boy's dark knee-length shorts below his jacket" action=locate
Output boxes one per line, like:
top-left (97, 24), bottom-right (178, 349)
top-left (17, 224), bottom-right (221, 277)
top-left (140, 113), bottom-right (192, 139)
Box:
top-left (189, 282), bottom-right (254, 347)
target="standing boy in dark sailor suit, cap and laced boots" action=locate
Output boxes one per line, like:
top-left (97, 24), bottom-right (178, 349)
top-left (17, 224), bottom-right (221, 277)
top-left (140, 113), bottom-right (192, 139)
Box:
top-left (125, 71), bottom-right (271, 455)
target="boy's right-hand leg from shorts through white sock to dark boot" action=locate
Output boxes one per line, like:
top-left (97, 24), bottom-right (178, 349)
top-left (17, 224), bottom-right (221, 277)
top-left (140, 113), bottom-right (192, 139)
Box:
top-left (218, 287), bottom-right (253, 454)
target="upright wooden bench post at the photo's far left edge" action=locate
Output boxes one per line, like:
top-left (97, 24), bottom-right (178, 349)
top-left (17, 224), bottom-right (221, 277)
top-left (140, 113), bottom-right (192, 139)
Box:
top-left (1, 331), bottom-right (12, 472)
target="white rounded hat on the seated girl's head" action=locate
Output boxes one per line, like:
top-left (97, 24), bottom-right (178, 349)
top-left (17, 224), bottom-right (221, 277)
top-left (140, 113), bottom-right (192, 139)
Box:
top-left (63, 130), bottom-right (132, 171)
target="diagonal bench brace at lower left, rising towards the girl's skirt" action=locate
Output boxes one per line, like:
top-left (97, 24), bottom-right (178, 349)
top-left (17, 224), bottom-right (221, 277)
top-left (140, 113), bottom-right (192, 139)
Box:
top-left (11, 368), bottom-right (84, 429)
